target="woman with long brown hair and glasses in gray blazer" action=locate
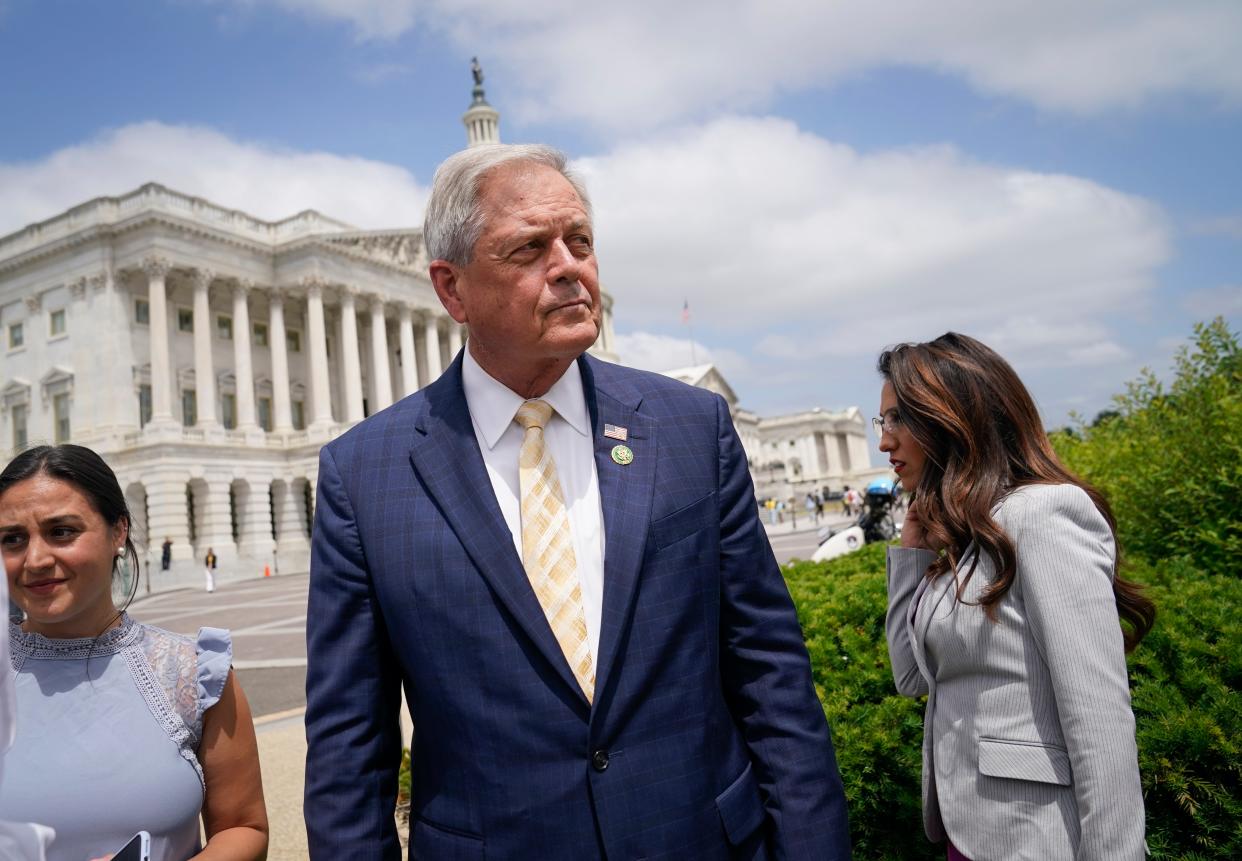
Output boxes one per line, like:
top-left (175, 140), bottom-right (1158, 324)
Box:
top-left (874, 332), bottom-right (1155, 861)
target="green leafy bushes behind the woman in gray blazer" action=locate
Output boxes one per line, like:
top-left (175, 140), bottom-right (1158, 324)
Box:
top-left (785, 319), bottom-right (1242, 861)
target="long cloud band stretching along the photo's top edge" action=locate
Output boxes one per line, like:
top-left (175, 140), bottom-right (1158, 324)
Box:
top-left (228, 0), bottom-right (1242, 129)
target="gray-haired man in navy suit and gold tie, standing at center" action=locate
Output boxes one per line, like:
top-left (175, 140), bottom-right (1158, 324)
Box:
top-left (306, 144), bottom-right (850, 861)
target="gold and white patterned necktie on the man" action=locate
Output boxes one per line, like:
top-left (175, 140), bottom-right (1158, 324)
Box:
top-left (513, 400), bottom-right (595, 702)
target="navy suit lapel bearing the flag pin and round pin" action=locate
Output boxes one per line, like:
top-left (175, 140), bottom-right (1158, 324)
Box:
top-left (580, 357), bottom-right (657, 706)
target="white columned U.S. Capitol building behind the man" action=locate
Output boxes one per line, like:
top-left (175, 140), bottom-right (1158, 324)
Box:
top-left (0, 77), bottom-right (864, 576)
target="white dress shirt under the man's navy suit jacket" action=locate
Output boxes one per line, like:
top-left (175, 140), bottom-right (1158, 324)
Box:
top-left (462, 349), bottom-right (604, 672)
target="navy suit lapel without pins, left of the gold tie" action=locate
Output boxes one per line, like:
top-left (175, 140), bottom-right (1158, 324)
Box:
top-left (410, 355), bottom-right (586, 707)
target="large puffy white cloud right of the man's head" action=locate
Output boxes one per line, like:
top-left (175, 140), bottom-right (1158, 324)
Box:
top-left (578, 112), bottom-right (1170, 359)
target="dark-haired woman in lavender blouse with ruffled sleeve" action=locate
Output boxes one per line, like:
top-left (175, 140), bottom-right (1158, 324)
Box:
top-left (0, 445), bottom-right (267, 861)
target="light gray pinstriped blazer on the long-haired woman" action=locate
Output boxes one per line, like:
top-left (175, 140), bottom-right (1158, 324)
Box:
top-left (886, 485), bottom-right (1146, 861)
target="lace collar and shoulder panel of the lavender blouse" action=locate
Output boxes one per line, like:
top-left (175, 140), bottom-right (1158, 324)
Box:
top-left (9, 614), bottom-right (219, 791)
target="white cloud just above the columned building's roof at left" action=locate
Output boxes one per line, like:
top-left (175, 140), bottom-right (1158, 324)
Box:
top-left (0, 122), bottom-right (427, 234)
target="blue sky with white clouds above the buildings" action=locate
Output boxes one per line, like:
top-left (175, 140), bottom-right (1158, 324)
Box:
top-left (0, 0), bottom-right (1242, 457)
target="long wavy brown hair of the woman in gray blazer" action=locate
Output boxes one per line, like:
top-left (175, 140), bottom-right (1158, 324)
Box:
top-left (878, 332), bottom-right (1156, 650)
